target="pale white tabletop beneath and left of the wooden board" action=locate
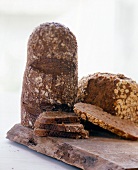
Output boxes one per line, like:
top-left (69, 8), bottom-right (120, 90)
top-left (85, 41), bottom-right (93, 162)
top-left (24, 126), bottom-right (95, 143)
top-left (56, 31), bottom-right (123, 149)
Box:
top-left (0, 93), bottom-right (78, 170)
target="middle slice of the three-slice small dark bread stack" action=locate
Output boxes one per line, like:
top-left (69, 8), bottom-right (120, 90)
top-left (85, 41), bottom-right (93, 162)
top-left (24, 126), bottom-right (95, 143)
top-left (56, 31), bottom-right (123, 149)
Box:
top-left (35, 121), bottom-right (84, 133)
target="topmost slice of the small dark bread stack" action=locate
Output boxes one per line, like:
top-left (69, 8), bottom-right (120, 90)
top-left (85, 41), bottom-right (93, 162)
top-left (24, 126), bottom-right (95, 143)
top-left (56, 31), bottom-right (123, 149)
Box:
top-left (35, 111), bottom-right (79, 126)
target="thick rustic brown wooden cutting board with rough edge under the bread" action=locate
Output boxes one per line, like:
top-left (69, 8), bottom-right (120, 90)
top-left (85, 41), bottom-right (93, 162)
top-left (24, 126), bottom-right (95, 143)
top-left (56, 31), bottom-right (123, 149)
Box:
top-left (7, 124), bottom-right (138, 170)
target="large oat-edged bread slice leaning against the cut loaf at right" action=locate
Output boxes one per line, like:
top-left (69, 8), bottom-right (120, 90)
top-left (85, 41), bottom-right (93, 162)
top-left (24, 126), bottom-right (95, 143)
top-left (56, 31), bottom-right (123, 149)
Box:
top-left (74, 103), bottom-right (138, 140)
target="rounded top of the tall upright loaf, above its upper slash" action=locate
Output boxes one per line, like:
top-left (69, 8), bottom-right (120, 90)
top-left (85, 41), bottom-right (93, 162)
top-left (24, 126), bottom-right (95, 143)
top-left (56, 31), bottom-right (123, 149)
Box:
top-left (27, 22), bottom-right (77, 64)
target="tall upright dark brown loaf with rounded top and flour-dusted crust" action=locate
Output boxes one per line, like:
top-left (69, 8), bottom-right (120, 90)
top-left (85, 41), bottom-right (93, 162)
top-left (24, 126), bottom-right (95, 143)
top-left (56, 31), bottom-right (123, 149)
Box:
top-left (21, 23), bottom-right (78, 127)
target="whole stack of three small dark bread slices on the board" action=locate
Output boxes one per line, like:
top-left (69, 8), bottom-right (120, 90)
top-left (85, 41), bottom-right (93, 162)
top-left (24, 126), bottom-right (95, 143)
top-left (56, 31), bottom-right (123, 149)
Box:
top-left (34, 111), bottom-right (89, 139)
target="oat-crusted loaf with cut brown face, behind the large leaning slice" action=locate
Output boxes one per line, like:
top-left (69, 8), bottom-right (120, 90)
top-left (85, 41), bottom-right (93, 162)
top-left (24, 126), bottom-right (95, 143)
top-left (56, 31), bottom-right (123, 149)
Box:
top-left (78, 73), bottom-right (138, 125)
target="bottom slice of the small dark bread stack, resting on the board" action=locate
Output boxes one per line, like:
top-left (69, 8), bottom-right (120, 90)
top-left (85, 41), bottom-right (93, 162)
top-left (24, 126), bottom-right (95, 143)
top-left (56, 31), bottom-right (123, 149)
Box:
top-left (34, 128), bottom-right (89, 139)
